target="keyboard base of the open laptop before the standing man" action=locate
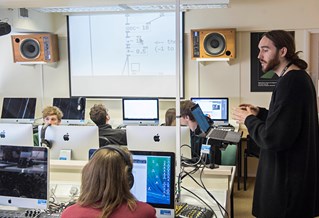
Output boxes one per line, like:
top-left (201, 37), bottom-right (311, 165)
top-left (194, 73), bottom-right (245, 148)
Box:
top-left (206, 129), bottom-right (243, 143)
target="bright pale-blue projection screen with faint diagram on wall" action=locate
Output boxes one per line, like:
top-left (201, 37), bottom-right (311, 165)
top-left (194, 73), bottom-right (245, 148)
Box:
top-left (69, 12), bottom-right (176, 76)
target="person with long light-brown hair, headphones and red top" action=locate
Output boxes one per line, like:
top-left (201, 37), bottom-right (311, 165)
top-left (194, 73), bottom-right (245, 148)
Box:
top-left (61, 145), bottom-right (156, 218)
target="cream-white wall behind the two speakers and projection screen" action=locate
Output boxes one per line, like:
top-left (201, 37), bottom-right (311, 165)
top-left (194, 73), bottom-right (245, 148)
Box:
top-left (0, 0), bottom-right (319, 124)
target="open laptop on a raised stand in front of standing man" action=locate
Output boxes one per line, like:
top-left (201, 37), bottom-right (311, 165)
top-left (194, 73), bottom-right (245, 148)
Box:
top-left (191, 104), bottom-right (242, 143)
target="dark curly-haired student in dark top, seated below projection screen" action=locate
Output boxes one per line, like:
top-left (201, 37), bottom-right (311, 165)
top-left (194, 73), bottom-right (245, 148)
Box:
top-left (90, 104), bottom-right (127, 145)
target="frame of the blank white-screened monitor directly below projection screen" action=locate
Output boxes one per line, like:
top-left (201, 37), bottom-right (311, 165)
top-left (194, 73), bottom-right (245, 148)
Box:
top-left (122, 98), bottom-right (159, 124)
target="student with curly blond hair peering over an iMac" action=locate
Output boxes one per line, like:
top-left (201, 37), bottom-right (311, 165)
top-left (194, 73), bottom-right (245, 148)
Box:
top-left (33, 106), bottom-right (63, 146)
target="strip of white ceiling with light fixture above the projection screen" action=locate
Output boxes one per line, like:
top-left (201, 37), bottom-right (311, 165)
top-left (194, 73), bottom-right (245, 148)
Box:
top-left (0, 0), bottom-right (229, 12)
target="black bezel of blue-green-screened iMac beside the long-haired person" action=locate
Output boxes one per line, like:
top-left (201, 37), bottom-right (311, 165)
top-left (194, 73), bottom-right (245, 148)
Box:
top-left (130, 150), bottom-right (176, 209)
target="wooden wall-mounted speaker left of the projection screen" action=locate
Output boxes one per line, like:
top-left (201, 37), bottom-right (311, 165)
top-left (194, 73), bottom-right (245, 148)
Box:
top-left (11, 33), bottom-right (59, 63)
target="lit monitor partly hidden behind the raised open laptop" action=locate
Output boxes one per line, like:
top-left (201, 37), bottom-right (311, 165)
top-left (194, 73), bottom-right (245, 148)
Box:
top-left (191, 98), bottom-right (229, 125)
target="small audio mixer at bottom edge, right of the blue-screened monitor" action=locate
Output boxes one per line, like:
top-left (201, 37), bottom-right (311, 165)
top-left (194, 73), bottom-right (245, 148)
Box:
top-left (175, 203), bottom-right (215, 218)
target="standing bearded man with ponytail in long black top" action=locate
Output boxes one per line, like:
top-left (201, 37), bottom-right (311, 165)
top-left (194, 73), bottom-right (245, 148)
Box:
top-left (233, 30), bottom-right (319, 218)
